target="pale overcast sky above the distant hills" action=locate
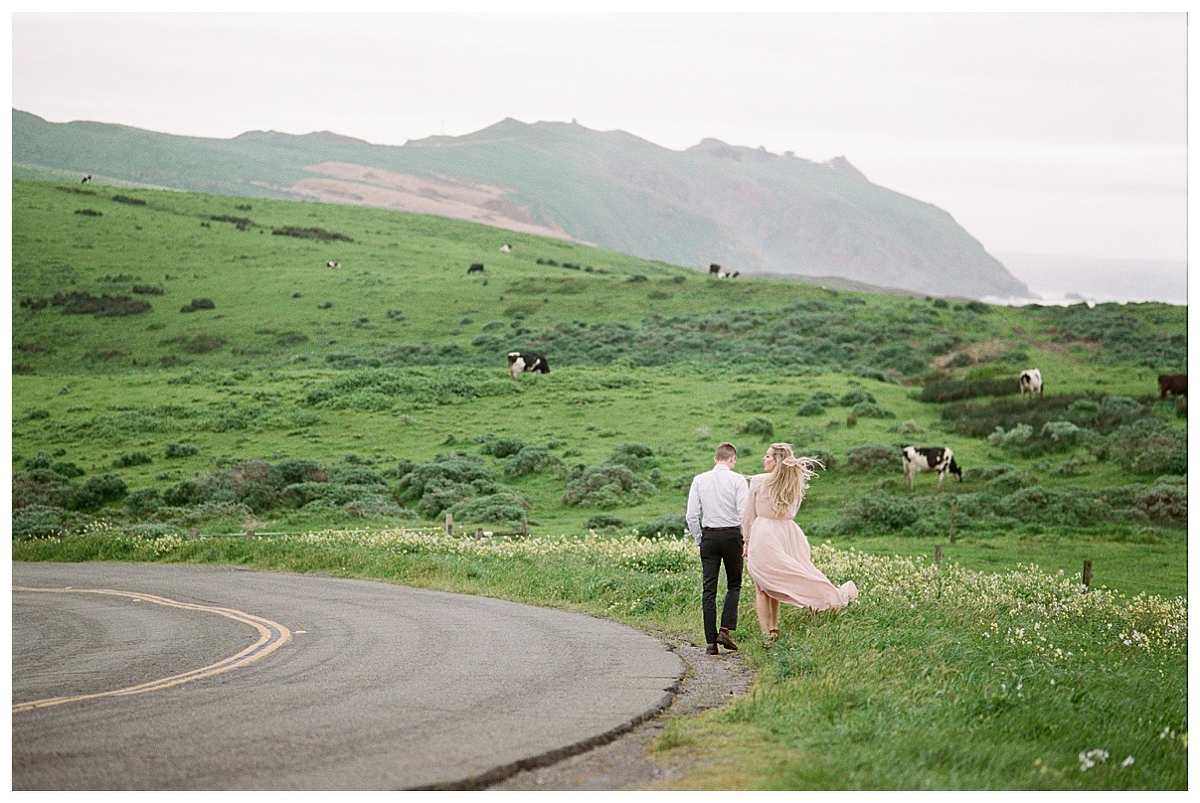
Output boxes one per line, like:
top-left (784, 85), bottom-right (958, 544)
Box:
top-left (12, 13), bottom-right (1187, 259)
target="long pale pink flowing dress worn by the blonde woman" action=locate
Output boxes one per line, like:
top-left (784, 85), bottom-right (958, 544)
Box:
top-left (742, 474), bottom-right (858, 611)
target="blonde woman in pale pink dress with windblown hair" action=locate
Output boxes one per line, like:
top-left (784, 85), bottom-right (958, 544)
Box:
top-left (742, 443), bottom-right (858, 641)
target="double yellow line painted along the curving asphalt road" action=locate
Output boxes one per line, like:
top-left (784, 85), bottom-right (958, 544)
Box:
top-left (12, 586), bottom-right (292, 714)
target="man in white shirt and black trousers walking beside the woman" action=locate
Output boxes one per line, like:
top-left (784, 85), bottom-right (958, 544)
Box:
top-left (686, 443), bottom-right (750, 655)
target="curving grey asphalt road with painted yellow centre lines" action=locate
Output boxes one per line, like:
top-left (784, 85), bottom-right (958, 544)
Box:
top-left (12, 563), bottom-right (685, 790)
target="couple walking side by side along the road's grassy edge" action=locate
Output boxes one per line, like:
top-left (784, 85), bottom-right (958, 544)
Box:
top-left (686, 443), bottom-right (858, 655)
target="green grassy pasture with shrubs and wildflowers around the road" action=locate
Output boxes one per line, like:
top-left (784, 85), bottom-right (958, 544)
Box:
top-left (12, 181), bottom-right (1187, 789)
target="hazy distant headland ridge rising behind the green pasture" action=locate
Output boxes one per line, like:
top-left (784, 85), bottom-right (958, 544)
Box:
top-left (12, 109), bottom-right (1031, 298)
